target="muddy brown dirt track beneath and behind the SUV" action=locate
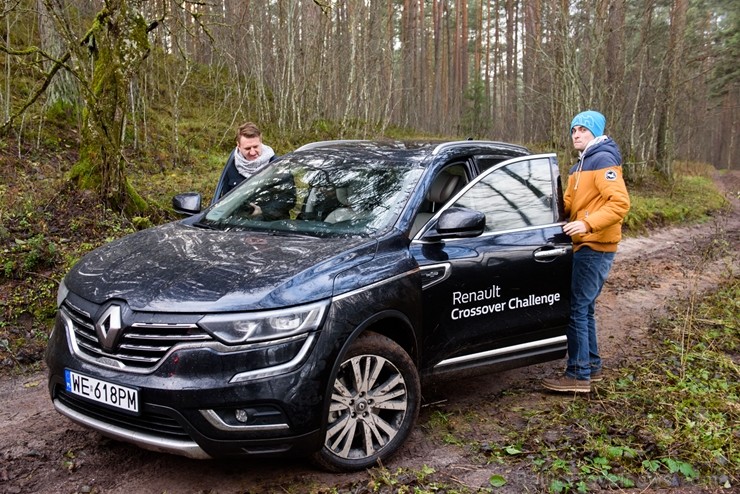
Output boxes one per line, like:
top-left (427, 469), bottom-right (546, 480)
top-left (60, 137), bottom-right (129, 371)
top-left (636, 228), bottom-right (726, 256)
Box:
top-left (0, 172), bottom-right (740, 494)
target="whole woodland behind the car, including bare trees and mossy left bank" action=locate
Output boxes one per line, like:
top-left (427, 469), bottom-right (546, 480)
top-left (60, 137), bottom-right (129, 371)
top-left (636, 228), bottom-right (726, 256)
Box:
top-left (0, 0), bottom-right (740, 366)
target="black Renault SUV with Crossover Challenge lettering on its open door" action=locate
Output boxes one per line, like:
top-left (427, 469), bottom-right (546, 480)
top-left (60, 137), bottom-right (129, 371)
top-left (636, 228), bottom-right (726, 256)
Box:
top-left (46, 141), bottom-right (571, 471)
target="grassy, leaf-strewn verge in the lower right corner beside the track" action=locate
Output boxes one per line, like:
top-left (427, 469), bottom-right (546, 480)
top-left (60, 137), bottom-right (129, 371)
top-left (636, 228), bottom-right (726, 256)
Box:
top-left (533, 278), bottom-right (740, 492)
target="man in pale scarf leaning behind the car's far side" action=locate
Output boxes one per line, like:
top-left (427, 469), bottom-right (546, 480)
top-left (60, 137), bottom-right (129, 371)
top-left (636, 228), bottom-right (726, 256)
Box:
top-left (213, 122), bottom-right (277, 202)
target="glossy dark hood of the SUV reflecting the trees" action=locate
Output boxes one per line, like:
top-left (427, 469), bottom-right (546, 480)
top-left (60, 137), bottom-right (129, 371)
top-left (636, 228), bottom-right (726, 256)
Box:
top-left (65, 222), bottom-right (377, 312)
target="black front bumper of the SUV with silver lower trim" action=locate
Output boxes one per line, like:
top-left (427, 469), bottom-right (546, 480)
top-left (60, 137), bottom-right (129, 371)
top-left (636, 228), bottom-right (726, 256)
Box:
top-left (46, 316), bottom-right (336, 458)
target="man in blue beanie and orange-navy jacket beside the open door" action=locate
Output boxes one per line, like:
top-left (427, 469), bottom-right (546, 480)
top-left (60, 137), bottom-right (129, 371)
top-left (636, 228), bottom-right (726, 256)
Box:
top-left (542, 110), bottom-right (630, 393)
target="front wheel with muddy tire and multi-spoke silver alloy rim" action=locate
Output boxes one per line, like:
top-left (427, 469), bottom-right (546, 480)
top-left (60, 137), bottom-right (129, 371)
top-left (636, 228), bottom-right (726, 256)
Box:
top-left (313, 333), bottom-right (421, 472)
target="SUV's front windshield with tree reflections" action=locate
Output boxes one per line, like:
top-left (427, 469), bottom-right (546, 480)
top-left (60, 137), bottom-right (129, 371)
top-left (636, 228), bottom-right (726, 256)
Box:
top-left (196, 155), bottom-right (422, 236)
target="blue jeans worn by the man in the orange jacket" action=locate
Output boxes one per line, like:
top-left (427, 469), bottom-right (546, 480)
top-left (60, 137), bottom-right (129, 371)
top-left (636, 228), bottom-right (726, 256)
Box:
top-left (565, 247), bottom-right (614, 380)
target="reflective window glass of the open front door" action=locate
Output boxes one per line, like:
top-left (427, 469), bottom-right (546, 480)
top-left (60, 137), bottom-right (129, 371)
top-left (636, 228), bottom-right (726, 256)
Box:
top-left (455, 158), bottom-right (556, 232)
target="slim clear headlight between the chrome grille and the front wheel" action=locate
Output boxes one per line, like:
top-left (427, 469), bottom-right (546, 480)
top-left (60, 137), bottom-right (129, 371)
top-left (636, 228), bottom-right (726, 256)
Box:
top-left (198, 302), bottom-right (329, 344)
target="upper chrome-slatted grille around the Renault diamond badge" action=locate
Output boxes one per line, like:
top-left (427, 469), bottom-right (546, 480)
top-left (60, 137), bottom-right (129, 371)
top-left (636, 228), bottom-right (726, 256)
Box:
top-left (60, 301), bottom-right (212, 372)
